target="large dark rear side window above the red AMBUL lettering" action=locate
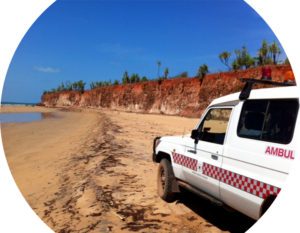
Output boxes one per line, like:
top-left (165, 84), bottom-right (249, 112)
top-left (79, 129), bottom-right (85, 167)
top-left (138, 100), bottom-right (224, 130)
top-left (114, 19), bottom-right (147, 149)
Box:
top-left (237, 99), bottom-right (299, 144)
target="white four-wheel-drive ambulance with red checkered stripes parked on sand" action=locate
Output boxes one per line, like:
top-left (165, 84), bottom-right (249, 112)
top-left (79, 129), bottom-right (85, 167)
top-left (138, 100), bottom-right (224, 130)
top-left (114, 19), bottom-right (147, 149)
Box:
top-left (153, 71), bottom-right (300, 219)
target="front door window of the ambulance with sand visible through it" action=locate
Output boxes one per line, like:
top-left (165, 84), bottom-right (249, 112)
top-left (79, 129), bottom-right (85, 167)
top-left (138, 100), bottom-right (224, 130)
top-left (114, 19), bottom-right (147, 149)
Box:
top-left (199, 108), bottom-right (231, 145)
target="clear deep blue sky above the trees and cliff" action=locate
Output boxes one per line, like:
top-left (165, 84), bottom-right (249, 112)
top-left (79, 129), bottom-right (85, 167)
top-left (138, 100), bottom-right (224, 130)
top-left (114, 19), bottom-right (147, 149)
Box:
top-left (2, 0), bottom-right (286, 102)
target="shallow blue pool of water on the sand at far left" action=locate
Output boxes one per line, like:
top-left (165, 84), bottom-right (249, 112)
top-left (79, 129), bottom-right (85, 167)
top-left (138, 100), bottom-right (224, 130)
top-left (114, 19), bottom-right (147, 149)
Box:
top-left (0, 112), bottom-right (55, 124)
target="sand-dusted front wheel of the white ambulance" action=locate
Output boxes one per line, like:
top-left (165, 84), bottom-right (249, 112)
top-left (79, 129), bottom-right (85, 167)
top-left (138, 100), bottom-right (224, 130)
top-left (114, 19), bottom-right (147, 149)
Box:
top-left (157, 159), bottom-right (175, 202)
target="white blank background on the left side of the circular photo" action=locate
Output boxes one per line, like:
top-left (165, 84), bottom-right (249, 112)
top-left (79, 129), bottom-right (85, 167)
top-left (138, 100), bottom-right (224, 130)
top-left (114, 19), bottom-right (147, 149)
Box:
top-left (0, 0), bottom-right (54, 233)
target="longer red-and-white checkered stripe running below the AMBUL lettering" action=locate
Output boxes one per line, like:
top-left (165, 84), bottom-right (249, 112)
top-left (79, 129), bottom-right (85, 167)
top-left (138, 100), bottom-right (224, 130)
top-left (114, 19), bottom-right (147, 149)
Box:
top-left (202, 163), bottom-right (280, 198)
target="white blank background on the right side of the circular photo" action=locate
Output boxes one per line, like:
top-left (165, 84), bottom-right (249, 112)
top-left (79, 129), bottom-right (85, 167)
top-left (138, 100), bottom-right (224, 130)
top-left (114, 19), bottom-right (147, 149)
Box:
top-left (246, 0), bottom-right (300, 233)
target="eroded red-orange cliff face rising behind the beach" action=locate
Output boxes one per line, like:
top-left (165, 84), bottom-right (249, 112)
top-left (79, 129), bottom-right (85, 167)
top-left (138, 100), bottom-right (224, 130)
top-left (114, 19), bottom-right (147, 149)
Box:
top-left (42, 65), bottom-right (291, 117)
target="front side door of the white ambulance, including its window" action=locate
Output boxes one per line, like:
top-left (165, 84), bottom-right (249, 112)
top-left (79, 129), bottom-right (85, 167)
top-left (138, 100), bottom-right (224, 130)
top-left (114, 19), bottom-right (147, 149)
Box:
top-left (182, 107), bottom-right (232, 198)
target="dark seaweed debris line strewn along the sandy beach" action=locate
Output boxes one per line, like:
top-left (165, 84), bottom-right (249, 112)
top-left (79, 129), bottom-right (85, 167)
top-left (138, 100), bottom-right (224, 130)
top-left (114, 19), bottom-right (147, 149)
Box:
top-left (43, 110), bottom-right (168, 233)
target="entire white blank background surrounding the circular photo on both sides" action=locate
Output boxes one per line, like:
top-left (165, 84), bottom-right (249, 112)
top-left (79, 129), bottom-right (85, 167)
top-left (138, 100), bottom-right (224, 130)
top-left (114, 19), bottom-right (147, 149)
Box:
top-left (0, 0), bottom-right (300, 233)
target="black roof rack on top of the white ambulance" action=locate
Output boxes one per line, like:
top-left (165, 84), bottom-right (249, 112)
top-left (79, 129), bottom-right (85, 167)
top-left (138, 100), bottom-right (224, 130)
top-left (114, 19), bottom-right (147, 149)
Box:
top-left (239, 78), bottom-right (296, 100)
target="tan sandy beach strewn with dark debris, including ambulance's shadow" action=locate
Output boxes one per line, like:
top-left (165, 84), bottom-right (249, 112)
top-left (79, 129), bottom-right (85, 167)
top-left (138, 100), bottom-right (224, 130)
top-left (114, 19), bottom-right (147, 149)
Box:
top-left (1, 106), bottom-right (254, 233)
